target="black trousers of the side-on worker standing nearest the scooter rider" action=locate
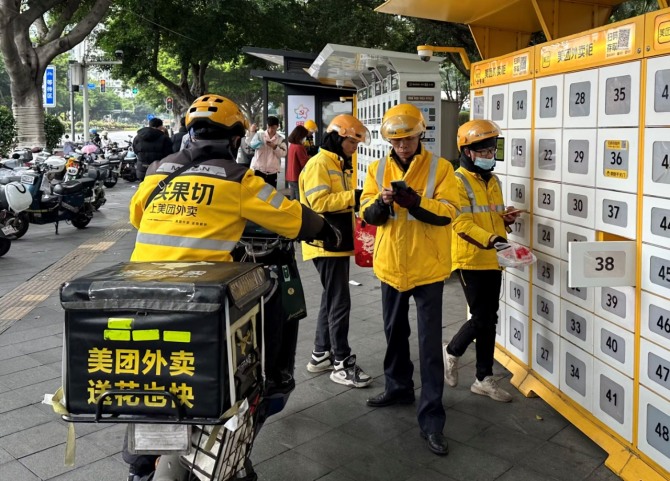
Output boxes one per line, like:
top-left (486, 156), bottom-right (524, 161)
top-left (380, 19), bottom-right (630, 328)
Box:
top-left (313, 256), bottom-right (351, 361)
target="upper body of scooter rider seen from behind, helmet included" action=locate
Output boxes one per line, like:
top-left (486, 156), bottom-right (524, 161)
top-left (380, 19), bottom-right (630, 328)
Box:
top-left (130, 94), bottom-right (342, 262)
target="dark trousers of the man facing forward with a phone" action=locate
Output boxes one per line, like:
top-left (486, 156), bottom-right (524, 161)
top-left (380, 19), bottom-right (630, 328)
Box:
top-left (382, 282), bottom-right (446, 434)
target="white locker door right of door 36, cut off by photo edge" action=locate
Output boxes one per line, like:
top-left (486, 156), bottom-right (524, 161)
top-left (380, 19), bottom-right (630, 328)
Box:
top-left (644, 128), bottom-right (670, 199)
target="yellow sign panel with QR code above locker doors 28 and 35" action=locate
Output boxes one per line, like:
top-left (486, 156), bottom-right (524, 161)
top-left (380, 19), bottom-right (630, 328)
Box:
top-left (536, 17), bottom-right (644, 76)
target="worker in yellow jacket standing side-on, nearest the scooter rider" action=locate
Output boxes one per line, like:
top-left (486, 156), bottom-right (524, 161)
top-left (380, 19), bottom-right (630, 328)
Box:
top-left (298, 114), bottom-right (372, 387)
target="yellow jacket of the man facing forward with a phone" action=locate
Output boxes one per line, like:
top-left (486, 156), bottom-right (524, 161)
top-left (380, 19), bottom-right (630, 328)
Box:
top-left (362, 145), bottom-right (460, 291)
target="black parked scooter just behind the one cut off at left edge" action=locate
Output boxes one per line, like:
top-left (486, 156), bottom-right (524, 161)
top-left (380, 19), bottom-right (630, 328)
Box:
top-left (21, 157), bottom-right (96, 234)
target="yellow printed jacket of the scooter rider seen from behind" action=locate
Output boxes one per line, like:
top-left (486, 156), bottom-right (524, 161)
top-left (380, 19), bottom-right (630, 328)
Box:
top-left (130, 140), bottom-right (308, 262)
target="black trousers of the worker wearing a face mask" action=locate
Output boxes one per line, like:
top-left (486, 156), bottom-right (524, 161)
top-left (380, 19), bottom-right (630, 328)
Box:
top-left (447, 269), bottom-right (502, 381)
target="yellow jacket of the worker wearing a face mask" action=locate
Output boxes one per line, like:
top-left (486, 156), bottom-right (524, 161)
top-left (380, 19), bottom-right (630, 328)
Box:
top-left (451, 167), bottom-right (507, 270)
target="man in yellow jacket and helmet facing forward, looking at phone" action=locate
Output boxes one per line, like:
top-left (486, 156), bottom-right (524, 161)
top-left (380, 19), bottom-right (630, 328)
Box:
top-left (361, 104), bottom-right (459, 455)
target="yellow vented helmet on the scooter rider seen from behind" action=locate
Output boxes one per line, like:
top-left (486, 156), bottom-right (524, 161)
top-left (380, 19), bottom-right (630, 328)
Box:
top-left (186, 94), bottom-right (249, 136)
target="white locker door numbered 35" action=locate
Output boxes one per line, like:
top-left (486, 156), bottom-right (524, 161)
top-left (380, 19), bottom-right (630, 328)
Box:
top-left (598, 60), bottom-right (640, 127)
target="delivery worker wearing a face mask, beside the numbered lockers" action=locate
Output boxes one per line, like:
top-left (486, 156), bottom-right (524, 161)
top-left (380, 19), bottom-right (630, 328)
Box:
top-left (443, 120), bottom-right (519, 402)
